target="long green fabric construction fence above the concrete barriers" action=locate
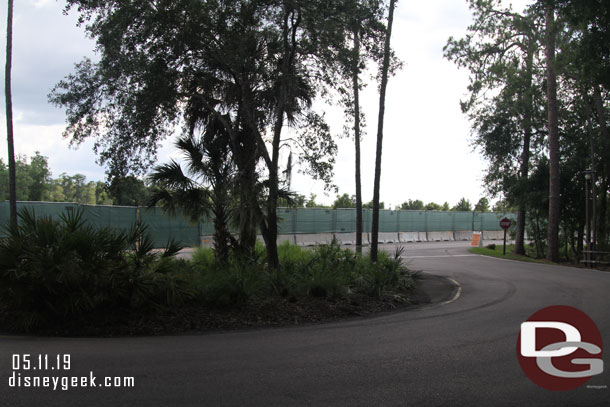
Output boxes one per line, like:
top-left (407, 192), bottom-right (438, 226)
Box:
top-left (0, 201), bottom-right (516, 247)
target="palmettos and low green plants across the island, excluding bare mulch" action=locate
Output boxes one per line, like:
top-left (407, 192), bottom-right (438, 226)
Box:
top-left (0, 210), bottom-right (412, 331)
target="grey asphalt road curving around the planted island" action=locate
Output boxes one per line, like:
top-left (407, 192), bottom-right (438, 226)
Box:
top-left (0, 242), bottom-right (610, 407)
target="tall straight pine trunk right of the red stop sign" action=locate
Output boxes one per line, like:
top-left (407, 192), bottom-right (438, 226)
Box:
top-left (546, 5), bottom-right (560, 262)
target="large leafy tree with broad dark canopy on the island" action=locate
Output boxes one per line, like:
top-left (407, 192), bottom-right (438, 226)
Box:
top-left (50, 0), bottom-right (356, 269)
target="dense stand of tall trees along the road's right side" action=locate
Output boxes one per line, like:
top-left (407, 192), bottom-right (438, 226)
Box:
top-left (444, 0), bottom-right (610, 261)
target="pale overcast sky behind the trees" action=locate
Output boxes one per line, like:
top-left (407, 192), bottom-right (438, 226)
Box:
top-left (0, 0), bottom-right (526, 207)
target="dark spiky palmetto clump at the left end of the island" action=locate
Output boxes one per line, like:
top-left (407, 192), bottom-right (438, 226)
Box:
top-left (0, 209), bottom-right (194, 330)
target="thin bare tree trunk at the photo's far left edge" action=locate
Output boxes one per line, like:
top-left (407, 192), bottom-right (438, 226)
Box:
top-left (4, 0), bottom-right (17, 228)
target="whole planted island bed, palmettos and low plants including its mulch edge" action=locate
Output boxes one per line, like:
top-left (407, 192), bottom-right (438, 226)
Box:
top-left (0, 210), bottom-right (414, 335)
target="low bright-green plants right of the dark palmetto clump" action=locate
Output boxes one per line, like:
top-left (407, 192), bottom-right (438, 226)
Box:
top-left (192, 241), bottom-right (412, 307)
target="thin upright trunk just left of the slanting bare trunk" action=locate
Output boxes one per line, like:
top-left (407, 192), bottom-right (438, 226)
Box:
top-left (352, 25), bottom-right (362, 253)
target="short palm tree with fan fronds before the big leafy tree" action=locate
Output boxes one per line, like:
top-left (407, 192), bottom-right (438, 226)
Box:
top-left (150, 116), bottom-right (236, 263)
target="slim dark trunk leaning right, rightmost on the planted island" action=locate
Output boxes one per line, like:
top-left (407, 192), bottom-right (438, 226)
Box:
top-left (371, 0), bottom-right (396, 262)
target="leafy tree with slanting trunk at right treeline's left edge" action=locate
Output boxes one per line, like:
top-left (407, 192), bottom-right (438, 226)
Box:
top-left (444, 0), bottom-right (542, 254)
